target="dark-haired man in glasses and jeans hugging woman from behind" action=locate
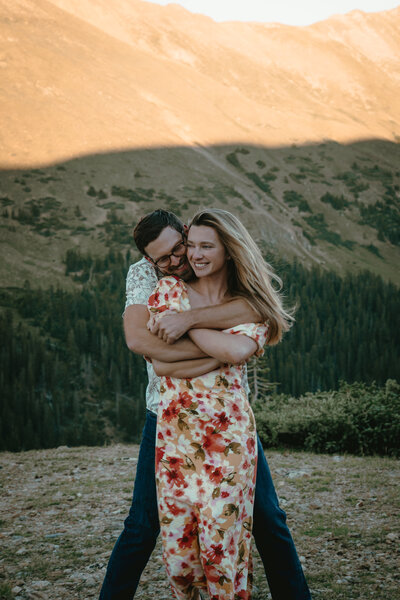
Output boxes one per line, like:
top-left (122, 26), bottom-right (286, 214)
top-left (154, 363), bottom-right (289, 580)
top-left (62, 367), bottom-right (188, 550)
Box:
top-left (100, 210), bottom-right (311, 600)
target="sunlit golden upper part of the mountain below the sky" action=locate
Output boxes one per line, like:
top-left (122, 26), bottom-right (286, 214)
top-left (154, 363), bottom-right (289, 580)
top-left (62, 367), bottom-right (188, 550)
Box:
top-left (0, 0), bottom-right (400, 168)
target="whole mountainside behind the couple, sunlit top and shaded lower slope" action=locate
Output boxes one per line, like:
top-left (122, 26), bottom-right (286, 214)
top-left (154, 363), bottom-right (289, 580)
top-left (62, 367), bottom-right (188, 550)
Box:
top-left (0, 0), bottom-right (400, 286)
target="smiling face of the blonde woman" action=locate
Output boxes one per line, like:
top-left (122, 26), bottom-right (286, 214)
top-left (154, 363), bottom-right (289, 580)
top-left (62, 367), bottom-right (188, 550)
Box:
top-left (187, 225), bottom-right (228, 277)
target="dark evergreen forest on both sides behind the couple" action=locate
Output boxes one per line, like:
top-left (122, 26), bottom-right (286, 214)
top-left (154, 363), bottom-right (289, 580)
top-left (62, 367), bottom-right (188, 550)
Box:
top-left (0, 250), bottom-right (400, 451)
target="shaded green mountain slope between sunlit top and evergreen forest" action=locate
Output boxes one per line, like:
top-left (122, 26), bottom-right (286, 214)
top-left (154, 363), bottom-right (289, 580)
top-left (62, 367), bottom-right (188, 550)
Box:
top-left (0, 140), bottom-right (400, 286)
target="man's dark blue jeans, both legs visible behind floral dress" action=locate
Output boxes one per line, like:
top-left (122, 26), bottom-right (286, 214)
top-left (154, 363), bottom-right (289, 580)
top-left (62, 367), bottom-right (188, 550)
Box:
top-left (99, 411), bottom-right (311, 600)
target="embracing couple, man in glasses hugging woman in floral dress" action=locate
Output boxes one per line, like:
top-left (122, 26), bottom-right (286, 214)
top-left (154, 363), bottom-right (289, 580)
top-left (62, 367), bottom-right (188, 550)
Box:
top-left (100, 209), bottom-right (310, 600)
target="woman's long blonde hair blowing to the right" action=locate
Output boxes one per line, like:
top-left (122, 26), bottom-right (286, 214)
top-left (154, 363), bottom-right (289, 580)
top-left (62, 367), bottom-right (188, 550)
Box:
top-left (189, 208), bottom-right (294, 345)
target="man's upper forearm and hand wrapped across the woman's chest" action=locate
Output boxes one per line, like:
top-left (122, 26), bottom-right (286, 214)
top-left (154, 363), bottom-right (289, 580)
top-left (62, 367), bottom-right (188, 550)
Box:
top-left (149, 298), bottom-right (261, 344)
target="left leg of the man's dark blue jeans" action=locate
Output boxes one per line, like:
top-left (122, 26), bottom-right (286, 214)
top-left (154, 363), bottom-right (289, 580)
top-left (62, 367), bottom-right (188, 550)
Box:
top-left (100, 411), bottom-right (160, 600)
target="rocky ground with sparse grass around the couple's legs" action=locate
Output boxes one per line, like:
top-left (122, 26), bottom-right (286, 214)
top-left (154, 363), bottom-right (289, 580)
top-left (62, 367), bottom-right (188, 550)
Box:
top-left (0, 445), bottom-right (400, 600)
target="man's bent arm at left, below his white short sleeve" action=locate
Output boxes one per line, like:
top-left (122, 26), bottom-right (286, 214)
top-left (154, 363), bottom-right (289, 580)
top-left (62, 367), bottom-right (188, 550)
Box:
top-left (124, 304), bottom-right (206, 362)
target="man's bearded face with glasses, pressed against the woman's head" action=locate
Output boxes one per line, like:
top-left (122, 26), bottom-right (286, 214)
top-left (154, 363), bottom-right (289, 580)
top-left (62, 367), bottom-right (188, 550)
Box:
top-left (145, 227), bottom-right (193, 281)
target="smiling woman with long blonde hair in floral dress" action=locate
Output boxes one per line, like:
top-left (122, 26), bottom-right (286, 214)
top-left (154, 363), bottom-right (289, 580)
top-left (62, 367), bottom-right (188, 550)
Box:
top-left (148, 209), bottom-right (291, 600)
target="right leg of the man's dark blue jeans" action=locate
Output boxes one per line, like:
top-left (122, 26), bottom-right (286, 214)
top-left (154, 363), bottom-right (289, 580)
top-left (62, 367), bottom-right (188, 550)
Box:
top-left (253, 436), bottom-right (311, 600)
